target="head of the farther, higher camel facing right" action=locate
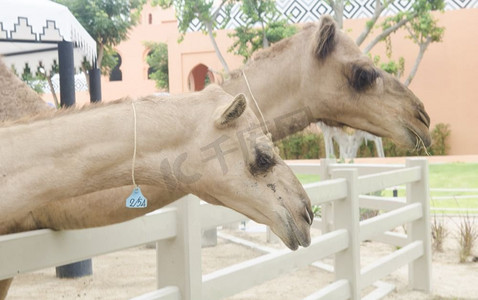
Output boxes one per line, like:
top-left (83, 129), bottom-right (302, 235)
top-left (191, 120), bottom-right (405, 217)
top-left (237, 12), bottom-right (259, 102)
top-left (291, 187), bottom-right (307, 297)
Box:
top-left (300, 16), bottom-right (431, 147)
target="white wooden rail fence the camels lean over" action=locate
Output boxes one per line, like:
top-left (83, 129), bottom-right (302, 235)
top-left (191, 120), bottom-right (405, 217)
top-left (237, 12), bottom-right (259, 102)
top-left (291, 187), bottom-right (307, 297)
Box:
top-left (0, 159), bottom-right (431, 300)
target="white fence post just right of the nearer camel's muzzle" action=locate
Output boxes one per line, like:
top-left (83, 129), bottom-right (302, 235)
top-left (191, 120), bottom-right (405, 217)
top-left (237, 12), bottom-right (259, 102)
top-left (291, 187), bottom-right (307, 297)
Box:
top-left (332, 169), bottom-right (360, 300)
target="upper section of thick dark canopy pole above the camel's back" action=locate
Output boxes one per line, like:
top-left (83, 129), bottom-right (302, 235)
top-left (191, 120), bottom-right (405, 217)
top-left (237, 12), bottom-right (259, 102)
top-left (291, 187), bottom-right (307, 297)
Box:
top-left (58, 41), bottom-right (75, 107)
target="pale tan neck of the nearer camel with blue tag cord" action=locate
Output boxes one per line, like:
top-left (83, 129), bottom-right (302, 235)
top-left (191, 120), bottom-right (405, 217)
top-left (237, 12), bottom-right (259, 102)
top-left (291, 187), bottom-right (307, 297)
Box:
top-left (0, 101), bottom-right (194, 216)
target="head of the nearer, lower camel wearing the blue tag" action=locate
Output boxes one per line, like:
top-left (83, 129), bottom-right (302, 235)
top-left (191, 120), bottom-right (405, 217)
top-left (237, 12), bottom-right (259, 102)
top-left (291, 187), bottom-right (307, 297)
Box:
top-left (183, 87), bottom-right (313, 250)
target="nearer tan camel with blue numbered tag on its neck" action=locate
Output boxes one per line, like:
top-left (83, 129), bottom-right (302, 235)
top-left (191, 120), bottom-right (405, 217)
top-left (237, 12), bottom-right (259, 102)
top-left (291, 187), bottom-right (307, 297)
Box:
top-left (0, 85), bottom-right (313, 249)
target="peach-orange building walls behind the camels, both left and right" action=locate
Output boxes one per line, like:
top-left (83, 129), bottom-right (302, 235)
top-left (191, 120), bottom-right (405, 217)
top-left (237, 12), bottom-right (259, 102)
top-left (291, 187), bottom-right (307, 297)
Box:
top-left (45, 6), bottom-right (478, 155)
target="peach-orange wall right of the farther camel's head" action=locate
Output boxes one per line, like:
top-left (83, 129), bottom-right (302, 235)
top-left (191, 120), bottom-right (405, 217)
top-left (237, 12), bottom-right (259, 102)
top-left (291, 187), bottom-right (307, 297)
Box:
top-left (344, 9), bottom-right (478, 155)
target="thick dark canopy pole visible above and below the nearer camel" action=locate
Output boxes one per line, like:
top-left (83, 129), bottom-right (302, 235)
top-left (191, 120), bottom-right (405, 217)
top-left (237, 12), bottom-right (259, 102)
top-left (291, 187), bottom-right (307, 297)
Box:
top-left (56, 41), bottom-right (93, 278)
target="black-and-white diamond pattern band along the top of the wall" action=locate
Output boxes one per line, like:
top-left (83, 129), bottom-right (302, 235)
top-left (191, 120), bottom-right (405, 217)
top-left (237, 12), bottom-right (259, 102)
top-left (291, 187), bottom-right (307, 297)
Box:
top-left (189, 0), bottom-right (478, 31)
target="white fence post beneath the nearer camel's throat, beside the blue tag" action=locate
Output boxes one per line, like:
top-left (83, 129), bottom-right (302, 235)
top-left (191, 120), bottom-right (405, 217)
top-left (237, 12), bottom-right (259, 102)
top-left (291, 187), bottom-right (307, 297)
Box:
top-left (156, 195), bottom-right (202, 300)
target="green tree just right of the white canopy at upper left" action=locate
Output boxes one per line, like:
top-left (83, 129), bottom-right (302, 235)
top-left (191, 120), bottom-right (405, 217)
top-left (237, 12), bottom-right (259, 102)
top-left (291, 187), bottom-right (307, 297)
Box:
top-left (54, 0), bottom-right (146, 74)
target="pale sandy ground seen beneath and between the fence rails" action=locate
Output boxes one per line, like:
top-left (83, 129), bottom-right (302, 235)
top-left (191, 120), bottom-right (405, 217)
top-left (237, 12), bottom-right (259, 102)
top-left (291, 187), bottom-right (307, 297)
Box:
top-left (7, 218), bottom-right (478, 300)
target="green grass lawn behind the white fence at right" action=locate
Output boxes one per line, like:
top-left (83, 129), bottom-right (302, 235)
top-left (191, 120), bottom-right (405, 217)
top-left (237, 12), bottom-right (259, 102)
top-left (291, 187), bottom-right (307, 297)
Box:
top-left (297, 163), bottom-right (478, 213)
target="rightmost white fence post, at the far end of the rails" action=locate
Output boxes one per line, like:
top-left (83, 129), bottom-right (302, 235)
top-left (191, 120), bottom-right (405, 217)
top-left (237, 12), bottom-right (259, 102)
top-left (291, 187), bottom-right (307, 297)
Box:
top-left (406, 158), bottom-right (432, 292)
